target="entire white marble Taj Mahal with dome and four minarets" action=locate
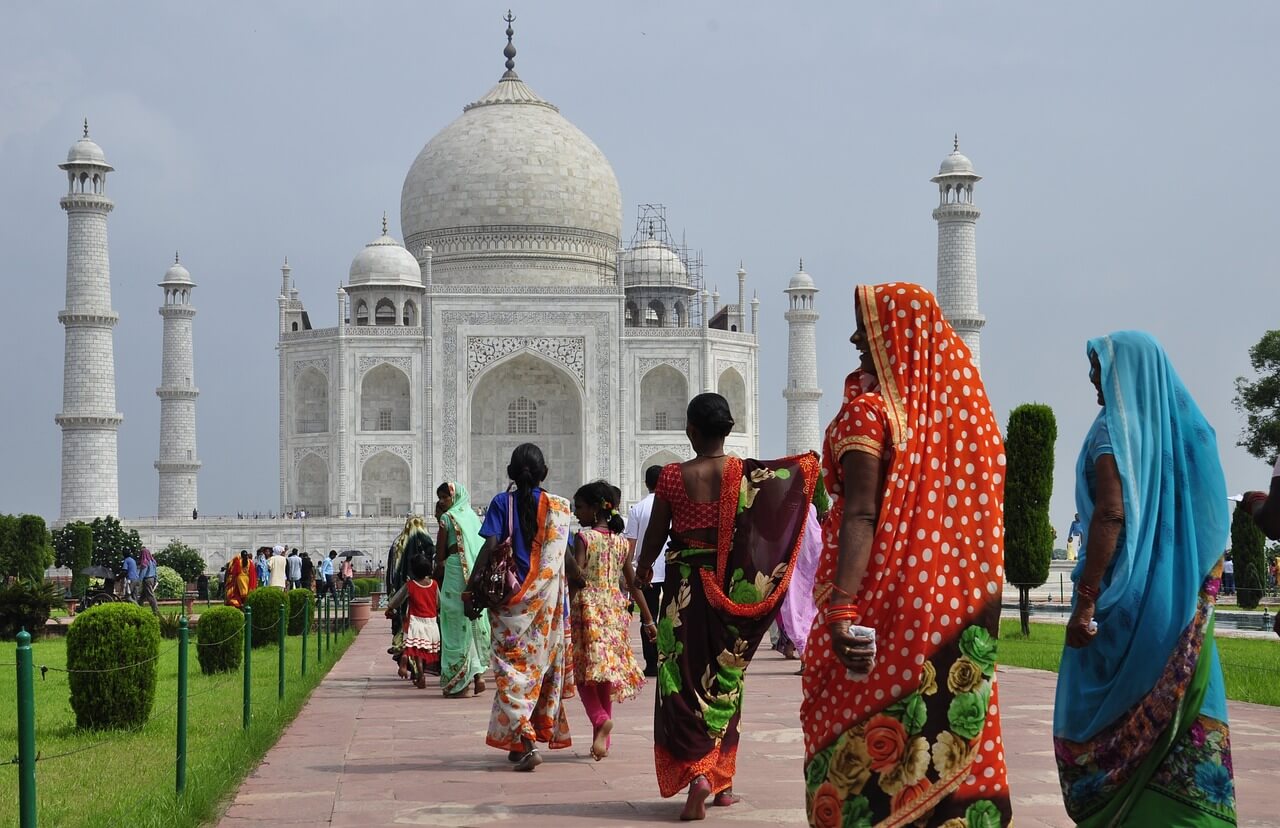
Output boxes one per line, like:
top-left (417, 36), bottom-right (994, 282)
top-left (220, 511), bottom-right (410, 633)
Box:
top-left (49, 20), bottom-right (984, 567)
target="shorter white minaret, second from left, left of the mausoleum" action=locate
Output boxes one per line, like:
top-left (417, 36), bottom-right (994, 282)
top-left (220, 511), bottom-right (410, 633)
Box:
top-left (155, 253), bottom-right (200, 518)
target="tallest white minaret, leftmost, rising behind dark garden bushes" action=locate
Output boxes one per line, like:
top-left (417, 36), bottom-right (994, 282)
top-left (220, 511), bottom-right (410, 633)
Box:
top-left (54, 119), bottom-right (124, 522)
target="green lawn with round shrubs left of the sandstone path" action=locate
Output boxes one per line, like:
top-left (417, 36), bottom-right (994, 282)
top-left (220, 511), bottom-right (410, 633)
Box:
top-left (0, 621), bottom-right (355, 827)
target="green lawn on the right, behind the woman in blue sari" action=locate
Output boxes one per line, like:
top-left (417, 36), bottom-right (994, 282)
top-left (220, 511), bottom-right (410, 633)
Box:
top-left (1000, 618), bottom-right (1280, 706)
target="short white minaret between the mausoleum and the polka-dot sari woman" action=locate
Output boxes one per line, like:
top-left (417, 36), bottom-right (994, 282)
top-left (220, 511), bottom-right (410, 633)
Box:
top-left (782, 259), bottom-right (822, 454)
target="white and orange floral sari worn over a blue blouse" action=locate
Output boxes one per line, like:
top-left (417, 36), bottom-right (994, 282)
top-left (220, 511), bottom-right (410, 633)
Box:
top-left (485, 491), bottom-right (573, 752)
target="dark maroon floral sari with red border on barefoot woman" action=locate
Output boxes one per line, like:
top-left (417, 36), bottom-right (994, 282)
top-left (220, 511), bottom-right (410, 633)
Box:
top-left (654, 454), bottom-right (818, 796)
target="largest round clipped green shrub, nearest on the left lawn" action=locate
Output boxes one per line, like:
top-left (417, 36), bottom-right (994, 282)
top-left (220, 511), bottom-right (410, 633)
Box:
top-left (67, 603), bottom-right (160, 729)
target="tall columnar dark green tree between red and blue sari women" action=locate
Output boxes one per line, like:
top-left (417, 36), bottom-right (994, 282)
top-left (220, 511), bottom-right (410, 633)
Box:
top-left (1005, 403), bottom-right (1057, 635)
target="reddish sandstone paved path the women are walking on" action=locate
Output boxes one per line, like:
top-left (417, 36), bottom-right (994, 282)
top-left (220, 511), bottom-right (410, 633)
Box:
top-left (220, 618), bottom-right (1280, 828)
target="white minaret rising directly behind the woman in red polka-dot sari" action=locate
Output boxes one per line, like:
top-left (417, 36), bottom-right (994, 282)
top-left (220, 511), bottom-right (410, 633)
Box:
top-left (929, 136), bottom-right (987, 367)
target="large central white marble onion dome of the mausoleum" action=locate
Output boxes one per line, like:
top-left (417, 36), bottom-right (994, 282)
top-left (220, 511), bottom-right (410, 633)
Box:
top-left (401, 69), bottom-right (622, 284)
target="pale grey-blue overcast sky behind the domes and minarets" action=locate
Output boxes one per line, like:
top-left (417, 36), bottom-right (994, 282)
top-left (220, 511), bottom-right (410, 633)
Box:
top-left (0, 0), bottom-right (1280, 535)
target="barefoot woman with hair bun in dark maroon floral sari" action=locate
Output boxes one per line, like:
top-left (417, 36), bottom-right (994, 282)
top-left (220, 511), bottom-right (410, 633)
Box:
top-left (639, 394), bottom-right (818, 820)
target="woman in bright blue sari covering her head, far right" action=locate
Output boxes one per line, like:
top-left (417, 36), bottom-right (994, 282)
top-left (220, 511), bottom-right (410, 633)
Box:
top-left (1053, 331), bottom-right (1235, 828)
